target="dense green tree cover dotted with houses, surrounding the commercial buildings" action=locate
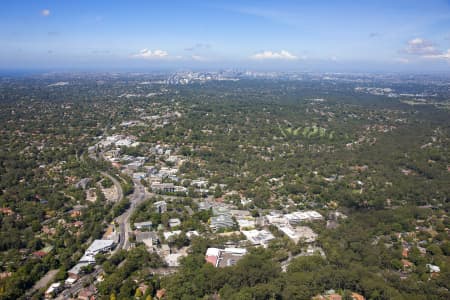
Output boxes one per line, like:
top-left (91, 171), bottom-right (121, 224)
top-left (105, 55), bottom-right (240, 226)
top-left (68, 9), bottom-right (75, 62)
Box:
top-left (0, 75), bottom-right (450, 299)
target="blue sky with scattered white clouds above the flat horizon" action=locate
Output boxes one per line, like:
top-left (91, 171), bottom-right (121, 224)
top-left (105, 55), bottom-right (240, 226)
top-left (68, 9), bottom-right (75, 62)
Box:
top-left (0, 0), bottom-right (450, 72)
